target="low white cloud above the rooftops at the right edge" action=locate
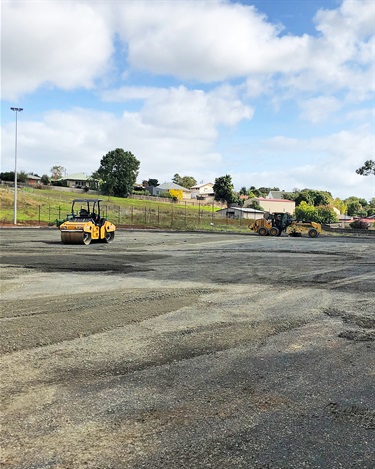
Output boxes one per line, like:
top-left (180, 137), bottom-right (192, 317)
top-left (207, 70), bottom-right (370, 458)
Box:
top-left (232, 127), bottom-right (375, 200)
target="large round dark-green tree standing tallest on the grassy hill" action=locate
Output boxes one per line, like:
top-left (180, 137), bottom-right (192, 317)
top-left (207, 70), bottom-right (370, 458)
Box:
top-left (96, 148), bottom-right (140, 197)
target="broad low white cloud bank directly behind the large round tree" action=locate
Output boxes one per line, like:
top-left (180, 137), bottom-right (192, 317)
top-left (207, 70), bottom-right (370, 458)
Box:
top-left (2, 83), bottom-right (252, 179)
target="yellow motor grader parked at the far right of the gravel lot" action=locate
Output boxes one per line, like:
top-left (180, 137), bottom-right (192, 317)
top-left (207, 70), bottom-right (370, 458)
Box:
top-left (249, 212), bottom-right (322, 238)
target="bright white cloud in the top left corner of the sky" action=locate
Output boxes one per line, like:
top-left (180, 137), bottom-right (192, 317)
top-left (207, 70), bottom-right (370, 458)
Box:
top-left (1, 0), bottom-right (113, 100)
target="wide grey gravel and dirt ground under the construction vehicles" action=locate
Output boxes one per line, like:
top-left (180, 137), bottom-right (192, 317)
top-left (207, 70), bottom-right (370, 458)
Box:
top-left (0, 228), bottom-right (375, 469)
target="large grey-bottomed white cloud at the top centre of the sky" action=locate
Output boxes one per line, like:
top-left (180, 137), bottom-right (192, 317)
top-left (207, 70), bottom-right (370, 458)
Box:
top-left (117, 1), bottom-right (309, 81)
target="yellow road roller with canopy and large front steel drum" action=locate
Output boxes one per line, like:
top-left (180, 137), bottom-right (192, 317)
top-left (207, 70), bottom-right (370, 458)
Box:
top-left (59, 199), bottom-right (116, 245)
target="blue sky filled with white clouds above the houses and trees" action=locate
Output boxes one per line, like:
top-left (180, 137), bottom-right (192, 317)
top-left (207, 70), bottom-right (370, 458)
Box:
top-left (1, 0), bottom-right (375, 200)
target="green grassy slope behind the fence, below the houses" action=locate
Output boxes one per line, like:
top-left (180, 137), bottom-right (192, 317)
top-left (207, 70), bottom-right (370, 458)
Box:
top-left (0, 186), bottom-right (249, 231)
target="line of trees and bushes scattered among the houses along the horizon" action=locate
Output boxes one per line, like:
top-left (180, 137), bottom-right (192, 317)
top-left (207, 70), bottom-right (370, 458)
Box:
top-left (0, 148), bottom-right (375, 223)
